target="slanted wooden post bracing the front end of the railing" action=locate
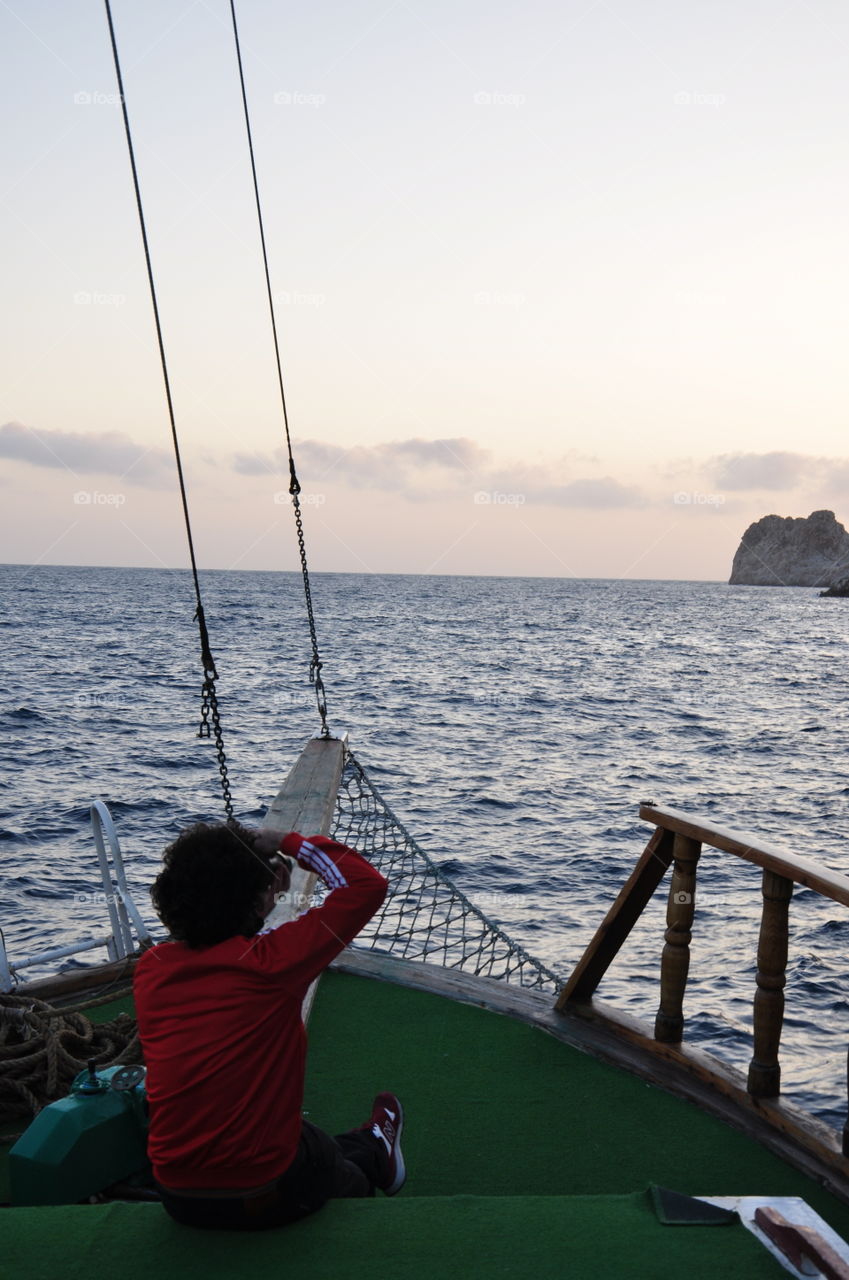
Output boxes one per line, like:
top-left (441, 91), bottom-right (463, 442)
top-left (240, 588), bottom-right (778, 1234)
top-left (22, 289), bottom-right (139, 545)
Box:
top-left (556, 827), bottom-right (674, 1010)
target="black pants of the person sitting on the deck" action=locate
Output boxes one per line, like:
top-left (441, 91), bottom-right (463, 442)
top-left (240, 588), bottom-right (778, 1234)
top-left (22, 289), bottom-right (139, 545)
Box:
top-left (159, 1120), bottom-right (387, 1231)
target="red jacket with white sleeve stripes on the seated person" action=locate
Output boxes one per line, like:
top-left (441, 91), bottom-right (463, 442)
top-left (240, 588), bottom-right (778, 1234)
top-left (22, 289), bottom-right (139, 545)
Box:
top-left (133, 833), bottom-right (387, 1190)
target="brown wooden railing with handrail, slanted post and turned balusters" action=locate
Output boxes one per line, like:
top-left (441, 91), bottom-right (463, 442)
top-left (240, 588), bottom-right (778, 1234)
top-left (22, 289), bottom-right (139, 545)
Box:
top-left (557, 804), bottom-right (849, 1156)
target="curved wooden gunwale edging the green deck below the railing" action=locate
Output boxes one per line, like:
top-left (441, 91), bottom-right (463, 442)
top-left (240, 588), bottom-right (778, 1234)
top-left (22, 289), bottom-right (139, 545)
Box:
top-left (330, 947), bottom-right (849, 1203)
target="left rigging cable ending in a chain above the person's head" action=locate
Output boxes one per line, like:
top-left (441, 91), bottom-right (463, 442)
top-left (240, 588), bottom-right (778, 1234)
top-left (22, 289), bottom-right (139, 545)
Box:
top-left (104, 0), bottom-right (233, 820)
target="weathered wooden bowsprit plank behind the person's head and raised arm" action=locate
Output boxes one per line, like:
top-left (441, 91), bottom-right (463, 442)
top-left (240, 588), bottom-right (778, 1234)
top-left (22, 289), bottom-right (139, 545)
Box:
top-left (261, 736), bottom-right (347, 1023)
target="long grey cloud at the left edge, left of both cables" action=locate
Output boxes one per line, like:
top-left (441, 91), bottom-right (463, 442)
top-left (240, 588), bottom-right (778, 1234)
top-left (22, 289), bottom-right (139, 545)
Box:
top-left (0, 422), bottom-right (174, 488)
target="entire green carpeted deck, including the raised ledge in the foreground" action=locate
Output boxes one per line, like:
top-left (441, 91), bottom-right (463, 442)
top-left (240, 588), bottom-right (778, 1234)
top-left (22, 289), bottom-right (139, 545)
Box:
top-left (0, 974), bottom-right (849, 1280)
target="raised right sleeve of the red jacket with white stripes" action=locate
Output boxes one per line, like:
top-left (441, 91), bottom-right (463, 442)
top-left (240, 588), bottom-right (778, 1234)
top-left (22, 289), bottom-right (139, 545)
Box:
top-left (255, 832), bottom-right (388, 991)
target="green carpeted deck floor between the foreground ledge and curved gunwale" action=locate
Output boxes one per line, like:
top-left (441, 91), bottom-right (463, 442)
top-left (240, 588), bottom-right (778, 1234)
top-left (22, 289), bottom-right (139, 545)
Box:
top-left (305, 974), bottom-right (849, 1238)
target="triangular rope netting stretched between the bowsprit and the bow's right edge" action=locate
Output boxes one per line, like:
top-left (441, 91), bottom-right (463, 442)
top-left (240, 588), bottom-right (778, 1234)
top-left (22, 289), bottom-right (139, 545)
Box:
top-left (333, 750), bottom-right (563, 992)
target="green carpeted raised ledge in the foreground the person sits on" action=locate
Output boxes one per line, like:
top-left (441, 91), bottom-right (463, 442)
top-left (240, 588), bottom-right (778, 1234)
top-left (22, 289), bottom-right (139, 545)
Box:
top-left (3, 1192), bottom-right (786, 1280)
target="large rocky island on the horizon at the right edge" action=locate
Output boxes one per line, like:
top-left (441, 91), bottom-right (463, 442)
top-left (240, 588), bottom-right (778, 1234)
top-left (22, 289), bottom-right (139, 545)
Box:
top-left (729, 511), bottom-right (849, 588)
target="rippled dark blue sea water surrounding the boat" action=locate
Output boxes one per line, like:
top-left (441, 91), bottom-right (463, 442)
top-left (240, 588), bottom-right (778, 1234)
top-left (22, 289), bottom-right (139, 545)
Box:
top-left (0, 566), bottom-right (849, 1123)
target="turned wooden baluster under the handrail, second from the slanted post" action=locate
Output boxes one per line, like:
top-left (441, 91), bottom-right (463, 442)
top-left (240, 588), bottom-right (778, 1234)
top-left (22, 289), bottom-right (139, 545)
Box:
top-left (748, 870), bottom-right (793, 1098)
